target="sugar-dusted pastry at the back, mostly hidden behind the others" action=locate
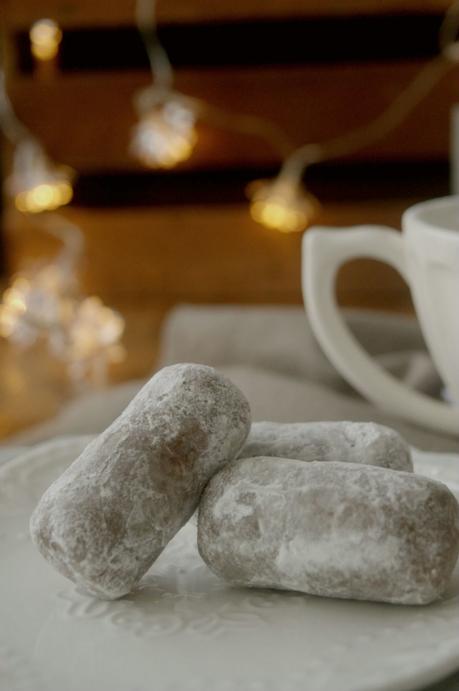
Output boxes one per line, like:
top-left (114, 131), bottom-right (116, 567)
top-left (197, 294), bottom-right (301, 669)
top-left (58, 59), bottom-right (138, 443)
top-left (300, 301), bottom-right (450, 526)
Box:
top-left (239, 422), bottom-right (413, 471)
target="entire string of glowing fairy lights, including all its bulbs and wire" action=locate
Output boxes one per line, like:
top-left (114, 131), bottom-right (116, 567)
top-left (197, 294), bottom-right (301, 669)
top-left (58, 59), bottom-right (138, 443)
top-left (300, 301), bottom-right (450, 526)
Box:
top-left (0, 0), bottom-right (459, 382)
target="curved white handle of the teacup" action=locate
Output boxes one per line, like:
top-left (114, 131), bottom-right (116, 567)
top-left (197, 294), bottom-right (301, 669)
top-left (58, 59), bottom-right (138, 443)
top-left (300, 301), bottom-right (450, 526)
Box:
top-left (302, 226), bottom-right (459, 435)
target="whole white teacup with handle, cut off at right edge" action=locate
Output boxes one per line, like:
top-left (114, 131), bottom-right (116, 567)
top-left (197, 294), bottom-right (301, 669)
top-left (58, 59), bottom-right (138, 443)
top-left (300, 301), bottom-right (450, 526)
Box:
top-left (302, 196), bottom-right (459, 435)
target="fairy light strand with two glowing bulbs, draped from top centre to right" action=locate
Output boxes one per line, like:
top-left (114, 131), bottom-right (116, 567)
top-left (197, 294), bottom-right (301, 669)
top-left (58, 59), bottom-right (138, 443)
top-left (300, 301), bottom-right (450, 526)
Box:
top-left (126, 0), bottom-right (459, 233)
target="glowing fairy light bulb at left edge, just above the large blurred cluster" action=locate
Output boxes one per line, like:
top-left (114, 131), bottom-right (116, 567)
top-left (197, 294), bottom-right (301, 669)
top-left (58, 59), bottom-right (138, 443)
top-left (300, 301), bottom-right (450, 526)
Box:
top-left (6, 139), bottom-right (74, 214)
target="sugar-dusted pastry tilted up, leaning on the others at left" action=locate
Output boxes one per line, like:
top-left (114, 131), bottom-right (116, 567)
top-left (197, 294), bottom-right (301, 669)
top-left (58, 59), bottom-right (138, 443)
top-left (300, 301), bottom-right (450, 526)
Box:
top-left (30, 364), bottom-right (250, 599)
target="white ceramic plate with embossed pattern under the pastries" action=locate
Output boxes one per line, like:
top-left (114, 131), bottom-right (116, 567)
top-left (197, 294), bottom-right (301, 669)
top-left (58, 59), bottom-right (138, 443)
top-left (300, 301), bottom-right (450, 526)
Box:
top-left (0, 438), bottom-right (459, 691)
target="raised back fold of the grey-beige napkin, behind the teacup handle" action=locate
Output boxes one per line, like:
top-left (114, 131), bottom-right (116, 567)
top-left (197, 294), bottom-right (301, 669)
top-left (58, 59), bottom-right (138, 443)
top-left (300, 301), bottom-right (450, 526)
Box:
top-left (159, 305), bottom-right (441, 396)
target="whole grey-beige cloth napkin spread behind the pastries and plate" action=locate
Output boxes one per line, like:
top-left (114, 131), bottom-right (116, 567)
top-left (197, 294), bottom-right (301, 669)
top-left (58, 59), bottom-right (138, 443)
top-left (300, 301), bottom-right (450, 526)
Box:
top-left (5, 305), bottom-right (459, 452)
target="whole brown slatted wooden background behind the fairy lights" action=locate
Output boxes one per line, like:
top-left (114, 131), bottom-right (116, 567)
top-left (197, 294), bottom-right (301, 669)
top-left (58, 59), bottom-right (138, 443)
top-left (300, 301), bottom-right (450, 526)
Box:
top-left (0, 0), bottom-right (459, 434)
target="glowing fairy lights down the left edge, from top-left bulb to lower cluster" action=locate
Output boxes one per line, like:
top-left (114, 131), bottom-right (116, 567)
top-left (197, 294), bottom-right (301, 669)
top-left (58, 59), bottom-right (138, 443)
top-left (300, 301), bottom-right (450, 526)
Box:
top-left (0, 29), bottom-right (124, 385)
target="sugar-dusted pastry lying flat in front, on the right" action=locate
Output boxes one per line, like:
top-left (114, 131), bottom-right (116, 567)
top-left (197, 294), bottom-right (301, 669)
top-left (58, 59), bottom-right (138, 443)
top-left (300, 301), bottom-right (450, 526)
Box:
top-left (198, 457), bottom-right (459, 605)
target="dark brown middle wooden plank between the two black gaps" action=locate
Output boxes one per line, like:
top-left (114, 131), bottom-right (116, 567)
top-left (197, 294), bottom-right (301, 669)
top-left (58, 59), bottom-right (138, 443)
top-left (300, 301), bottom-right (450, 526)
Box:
top-left (10, 61), bottom-right (459, 171)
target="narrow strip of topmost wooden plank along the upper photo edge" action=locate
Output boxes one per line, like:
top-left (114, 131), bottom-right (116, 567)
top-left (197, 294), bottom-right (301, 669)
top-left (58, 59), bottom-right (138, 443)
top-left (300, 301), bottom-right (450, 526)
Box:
top-left (4, 0), bottom-right (450, 29)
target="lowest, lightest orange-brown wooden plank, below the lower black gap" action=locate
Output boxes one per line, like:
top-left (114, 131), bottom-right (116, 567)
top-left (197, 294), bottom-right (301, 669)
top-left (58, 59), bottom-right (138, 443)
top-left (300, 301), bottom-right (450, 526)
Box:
top-left (3, 199), bottom-right (416, 309)
